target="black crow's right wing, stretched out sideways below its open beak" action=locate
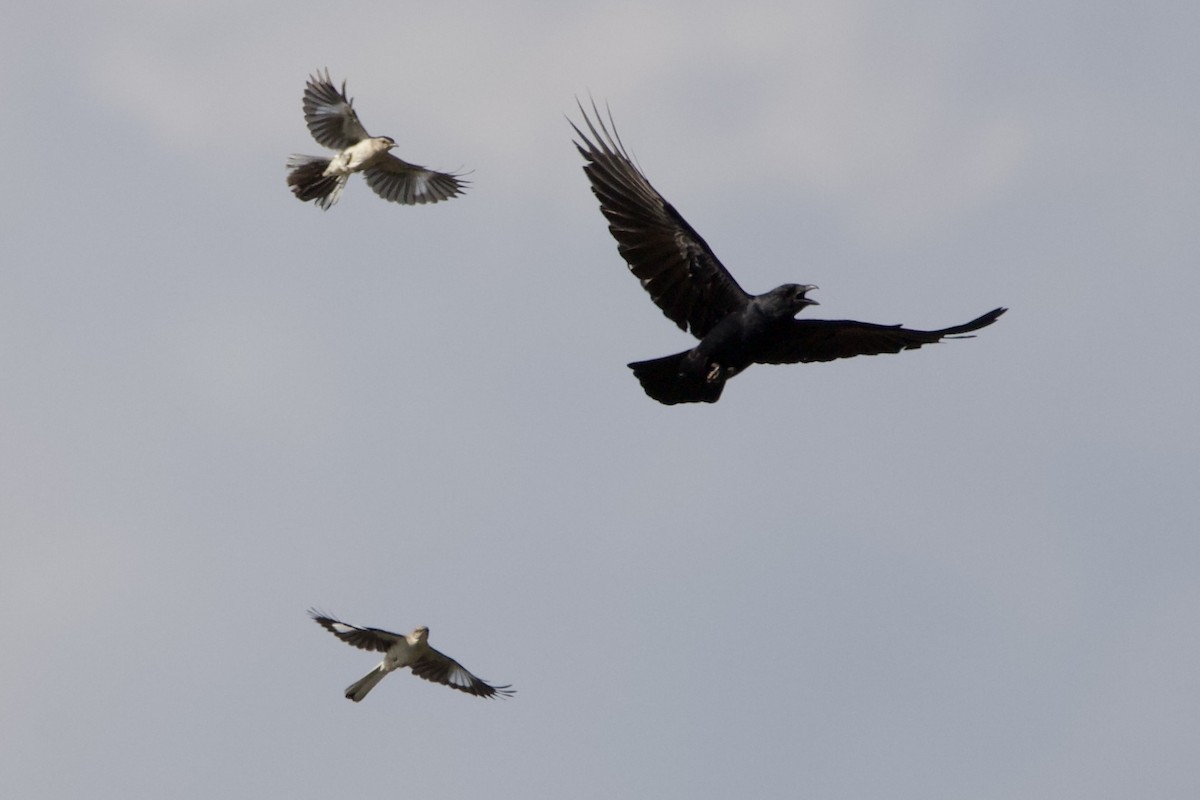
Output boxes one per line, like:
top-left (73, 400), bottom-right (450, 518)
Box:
top-left (755, 308), bottom-right (1007, 363)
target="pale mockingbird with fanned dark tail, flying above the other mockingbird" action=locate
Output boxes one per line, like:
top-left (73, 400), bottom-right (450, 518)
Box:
top-left (288, 70), bottom-right (466, 210)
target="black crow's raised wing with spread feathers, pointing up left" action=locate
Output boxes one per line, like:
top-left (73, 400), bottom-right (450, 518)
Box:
top-left (571, 103), bottom-right (750, 338)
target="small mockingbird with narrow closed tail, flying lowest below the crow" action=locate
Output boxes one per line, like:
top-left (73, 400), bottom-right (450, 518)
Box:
top-left (308, 609), bottom-right (516, 703)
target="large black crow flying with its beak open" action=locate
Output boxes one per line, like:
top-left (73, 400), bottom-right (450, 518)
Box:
top-left (571, 103), bottom-right (1007, 405)
